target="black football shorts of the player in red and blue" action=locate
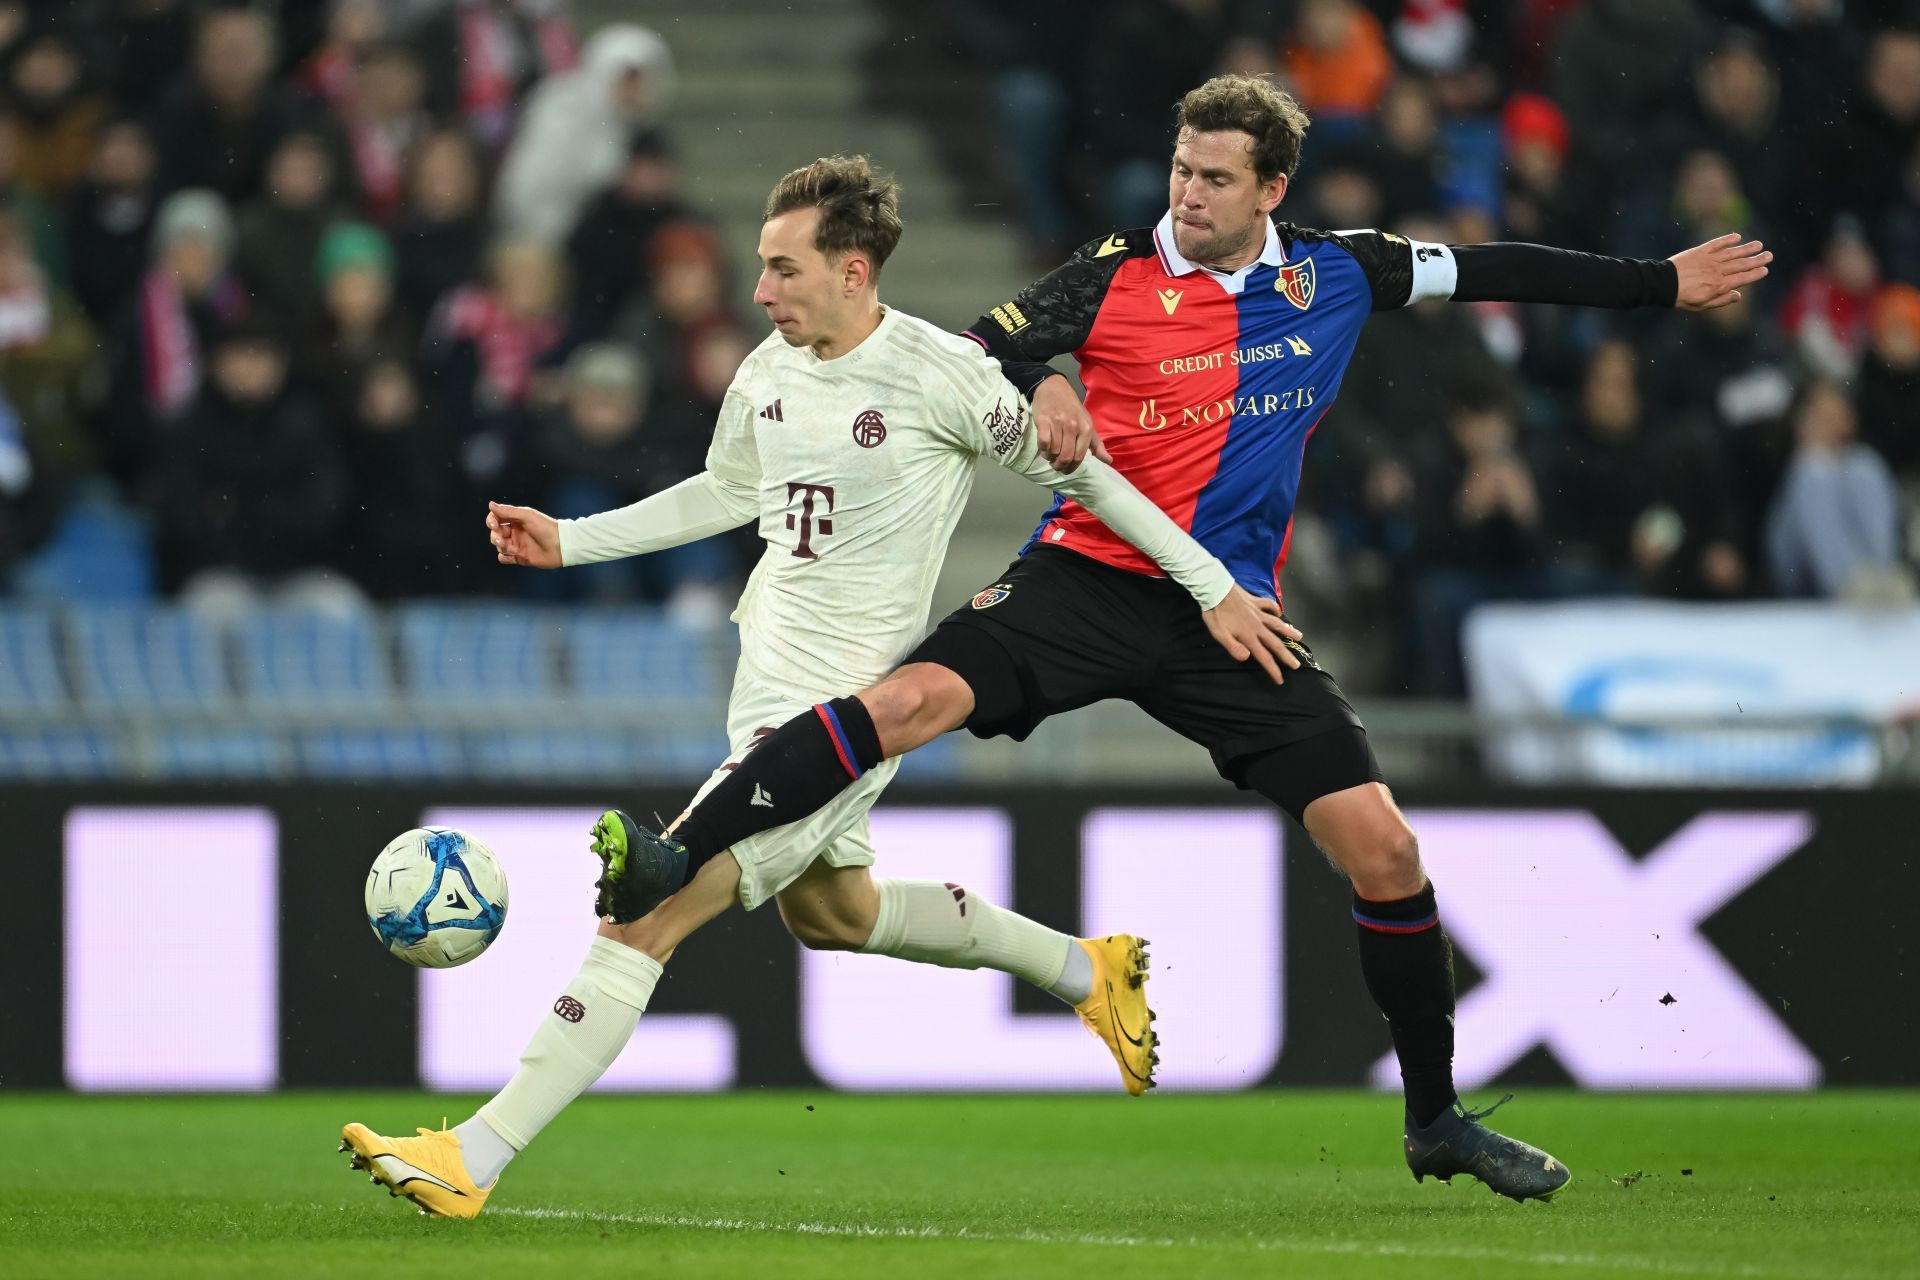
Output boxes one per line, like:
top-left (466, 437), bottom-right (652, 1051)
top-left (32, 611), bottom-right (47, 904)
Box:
top-left (906, 545), bottom-right (1380, 793)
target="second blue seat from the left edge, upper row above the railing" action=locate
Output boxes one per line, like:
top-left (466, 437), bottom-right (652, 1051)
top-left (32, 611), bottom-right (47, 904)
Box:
top-left (71, 604), bottom-right (232, 712)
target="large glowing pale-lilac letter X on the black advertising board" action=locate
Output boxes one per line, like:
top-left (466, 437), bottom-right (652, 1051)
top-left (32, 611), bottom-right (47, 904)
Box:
top-left (1373, 810), bottom-right (1820, 1088)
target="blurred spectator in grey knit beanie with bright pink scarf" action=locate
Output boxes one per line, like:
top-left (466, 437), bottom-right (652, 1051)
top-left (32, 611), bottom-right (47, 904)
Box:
top-left (100, 190), bottom-right (246, 484)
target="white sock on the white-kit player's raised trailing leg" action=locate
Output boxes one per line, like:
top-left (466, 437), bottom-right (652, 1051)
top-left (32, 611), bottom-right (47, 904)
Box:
top-left (860, 881), bottom-right (1092, 1004)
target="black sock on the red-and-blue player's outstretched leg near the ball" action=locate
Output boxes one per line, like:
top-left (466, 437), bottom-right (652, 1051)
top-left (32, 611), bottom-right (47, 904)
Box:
top-left (674, 699), bottom-right (885, 879)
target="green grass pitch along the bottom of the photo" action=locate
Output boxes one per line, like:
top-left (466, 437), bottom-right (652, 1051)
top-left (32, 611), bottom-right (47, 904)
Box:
top-left (0, 1090), bottom-right (1920, 1280)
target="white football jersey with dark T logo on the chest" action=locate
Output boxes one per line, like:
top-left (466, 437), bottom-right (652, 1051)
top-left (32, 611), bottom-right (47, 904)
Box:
top-left (707, 309), bottom-right (1058, 697)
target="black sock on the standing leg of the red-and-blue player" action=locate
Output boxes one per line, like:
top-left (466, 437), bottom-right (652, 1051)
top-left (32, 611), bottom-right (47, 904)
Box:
top-left (1354, 883), bottom-right (1455, 1128)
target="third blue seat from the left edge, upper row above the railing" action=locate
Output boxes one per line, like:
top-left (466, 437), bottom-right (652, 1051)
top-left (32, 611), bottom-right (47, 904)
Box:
top-left (240, 608), bottom-right (394, 710)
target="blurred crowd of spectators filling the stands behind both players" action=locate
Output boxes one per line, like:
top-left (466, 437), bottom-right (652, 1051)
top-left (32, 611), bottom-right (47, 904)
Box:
top-left (0, 0), bottom-right (1920, 693)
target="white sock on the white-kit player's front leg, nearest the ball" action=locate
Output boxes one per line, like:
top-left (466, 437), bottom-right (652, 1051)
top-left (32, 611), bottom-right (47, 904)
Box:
top-left (453, 936), bottom-right (660, 1186)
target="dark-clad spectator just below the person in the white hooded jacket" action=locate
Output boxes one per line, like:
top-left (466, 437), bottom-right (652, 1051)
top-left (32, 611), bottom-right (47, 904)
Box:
top-left (566, 129), bottom-right (687, 338)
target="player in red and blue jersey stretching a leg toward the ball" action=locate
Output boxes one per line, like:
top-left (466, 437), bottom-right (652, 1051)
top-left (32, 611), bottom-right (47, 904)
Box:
top-left (607, 77), bottom-right (1772, 1199)
